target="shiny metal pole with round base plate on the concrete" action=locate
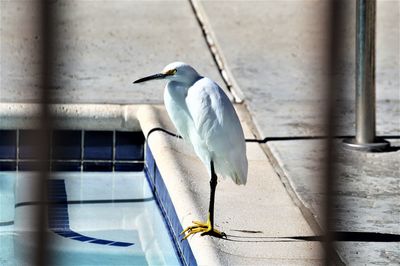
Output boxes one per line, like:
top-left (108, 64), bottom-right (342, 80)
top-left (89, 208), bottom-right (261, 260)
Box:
top-left (344, 0), bottom-right (389, 151)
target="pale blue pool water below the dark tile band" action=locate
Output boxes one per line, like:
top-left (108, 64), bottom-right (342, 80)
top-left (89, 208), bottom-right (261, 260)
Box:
top-left (0, 172), bottom-right (180, 266)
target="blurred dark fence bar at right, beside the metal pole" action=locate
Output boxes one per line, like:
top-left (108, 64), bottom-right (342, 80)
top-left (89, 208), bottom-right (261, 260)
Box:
top-left (321, 0), bottom-right (347, 266)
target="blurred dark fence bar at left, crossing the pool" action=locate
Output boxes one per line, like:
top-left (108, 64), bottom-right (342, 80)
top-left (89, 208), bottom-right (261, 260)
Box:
top-left (30, 0), bottom-right (57, 266)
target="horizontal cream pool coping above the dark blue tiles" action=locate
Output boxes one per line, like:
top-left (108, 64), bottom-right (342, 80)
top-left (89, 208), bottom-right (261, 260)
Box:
top-left (0, 103), bottom-right (142, 131)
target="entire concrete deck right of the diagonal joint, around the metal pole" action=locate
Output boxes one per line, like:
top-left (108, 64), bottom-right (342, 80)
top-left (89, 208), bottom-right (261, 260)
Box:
top-left (197, 0), bottom-right (400, 265)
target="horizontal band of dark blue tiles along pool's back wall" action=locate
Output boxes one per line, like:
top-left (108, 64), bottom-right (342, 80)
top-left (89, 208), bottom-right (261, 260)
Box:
top-left (0, 129), bottom-right (144, 172)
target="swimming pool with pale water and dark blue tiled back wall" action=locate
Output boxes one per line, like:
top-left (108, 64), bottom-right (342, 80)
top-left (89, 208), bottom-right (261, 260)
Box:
top-left (0, 129), bottom-right (182, 266)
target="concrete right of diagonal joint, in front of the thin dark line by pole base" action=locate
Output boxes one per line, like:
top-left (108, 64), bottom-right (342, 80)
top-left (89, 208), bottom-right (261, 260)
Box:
top-left (263, 139), bottom-right (400, 265)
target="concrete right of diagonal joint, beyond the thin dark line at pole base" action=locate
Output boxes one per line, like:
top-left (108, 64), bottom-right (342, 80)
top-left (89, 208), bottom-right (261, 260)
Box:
top-left (199, 0), bottom-right (400, 137)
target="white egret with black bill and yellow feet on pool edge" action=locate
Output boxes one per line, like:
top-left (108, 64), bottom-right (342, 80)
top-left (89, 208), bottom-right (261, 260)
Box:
top-left (134, 62), bottom-right (247, 239)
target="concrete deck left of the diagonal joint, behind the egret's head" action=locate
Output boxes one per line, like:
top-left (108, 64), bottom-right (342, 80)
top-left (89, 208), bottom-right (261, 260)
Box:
top-left (0, 0), bottom-right (224, 103)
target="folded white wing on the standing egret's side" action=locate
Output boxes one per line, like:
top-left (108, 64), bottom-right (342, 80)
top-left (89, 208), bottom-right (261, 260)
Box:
top-left (186, 78), bottom-right (247, 184)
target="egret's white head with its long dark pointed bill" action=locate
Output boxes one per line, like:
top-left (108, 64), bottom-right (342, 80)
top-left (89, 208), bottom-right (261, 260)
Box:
top-left (133, 62), bottom-right (200, 84)
